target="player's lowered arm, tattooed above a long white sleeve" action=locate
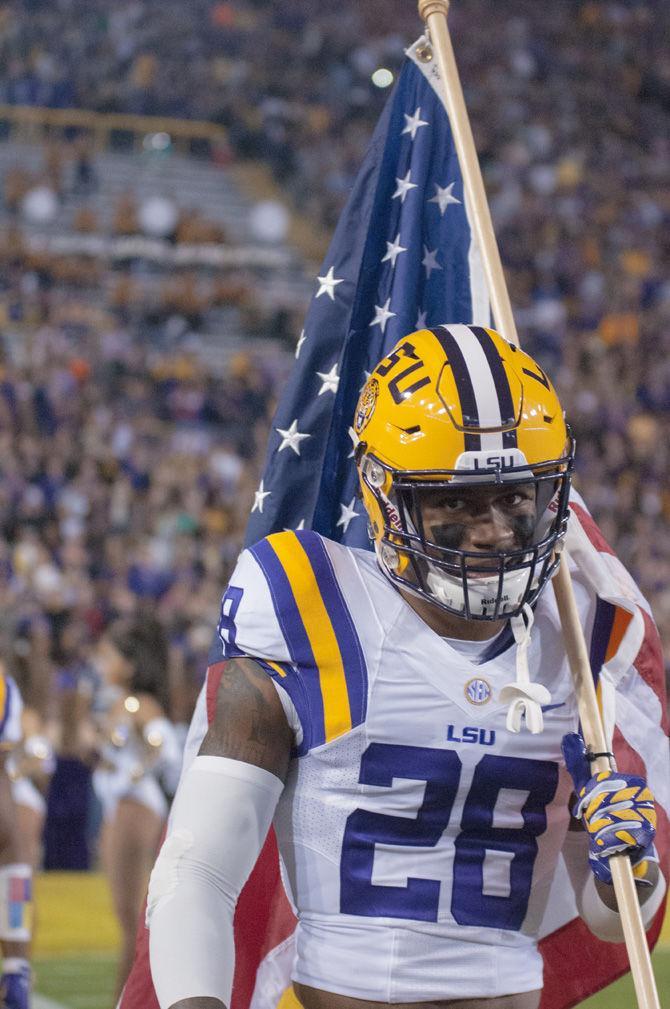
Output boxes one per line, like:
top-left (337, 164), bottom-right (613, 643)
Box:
top-left (149, 659), bottom-right (294, 1009)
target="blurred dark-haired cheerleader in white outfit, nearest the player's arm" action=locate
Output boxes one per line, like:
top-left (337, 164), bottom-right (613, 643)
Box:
top-left (93, 618), bottom-right (183, 1001)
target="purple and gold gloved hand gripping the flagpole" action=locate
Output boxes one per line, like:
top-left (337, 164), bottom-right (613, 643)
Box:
top-left (562, 733), bottom-right (658, 886)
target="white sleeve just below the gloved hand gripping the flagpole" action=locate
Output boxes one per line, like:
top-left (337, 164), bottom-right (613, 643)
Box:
top-left (563, 830), bottom-right (666, 942)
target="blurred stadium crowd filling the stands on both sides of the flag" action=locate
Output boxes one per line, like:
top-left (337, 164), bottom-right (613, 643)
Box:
top-left (0, 0), bottom-right (670, 879)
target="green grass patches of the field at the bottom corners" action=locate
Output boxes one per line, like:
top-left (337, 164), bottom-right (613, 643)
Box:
top-left (34, 947), bottom-right (670, 1009)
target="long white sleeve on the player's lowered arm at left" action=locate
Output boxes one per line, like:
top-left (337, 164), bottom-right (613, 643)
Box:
top-left (146, 756), bottom-right (284, 1009)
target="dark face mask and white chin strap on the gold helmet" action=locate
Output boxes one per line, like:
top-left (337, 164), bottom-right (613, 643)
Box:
top-left (362, 451), bottom-right (572, 621)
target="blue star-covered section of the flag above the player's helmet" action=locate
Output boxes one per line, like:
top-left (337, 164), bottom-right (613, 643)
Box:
top-left (246, 45), bottom-right (487, 546)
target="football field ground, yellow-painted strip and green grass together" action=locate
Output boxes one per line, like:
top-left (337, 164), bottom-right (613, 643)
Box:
top-left (33, 873), bottom-right (670, 1009)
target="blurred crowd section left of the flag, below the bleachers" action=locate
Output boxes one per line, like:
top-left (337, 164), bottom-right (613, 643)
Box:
top-left (0, 263), bottom-right (272, 718)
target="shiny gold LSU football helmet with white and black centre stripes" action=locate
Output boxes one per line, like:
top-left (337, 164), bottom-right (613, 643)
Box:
top-left (353, 325), bottom-right (574, 621)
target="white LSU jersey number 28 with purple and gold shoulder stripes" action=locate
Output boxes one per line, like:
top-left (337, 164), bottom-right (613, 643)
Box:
top-left (214, 532), bottom-right (609, 1002)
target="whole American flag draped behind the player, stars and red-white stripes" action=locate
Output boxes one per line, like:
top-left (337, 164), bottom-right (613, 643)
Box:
top-left (119, 39), bottom-right (670, 1009)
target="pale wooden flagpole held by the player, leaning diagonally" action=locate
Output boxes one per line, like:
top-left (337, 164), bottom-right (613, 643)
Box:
top-left (419, 0), bottom-right (661, 1009)
